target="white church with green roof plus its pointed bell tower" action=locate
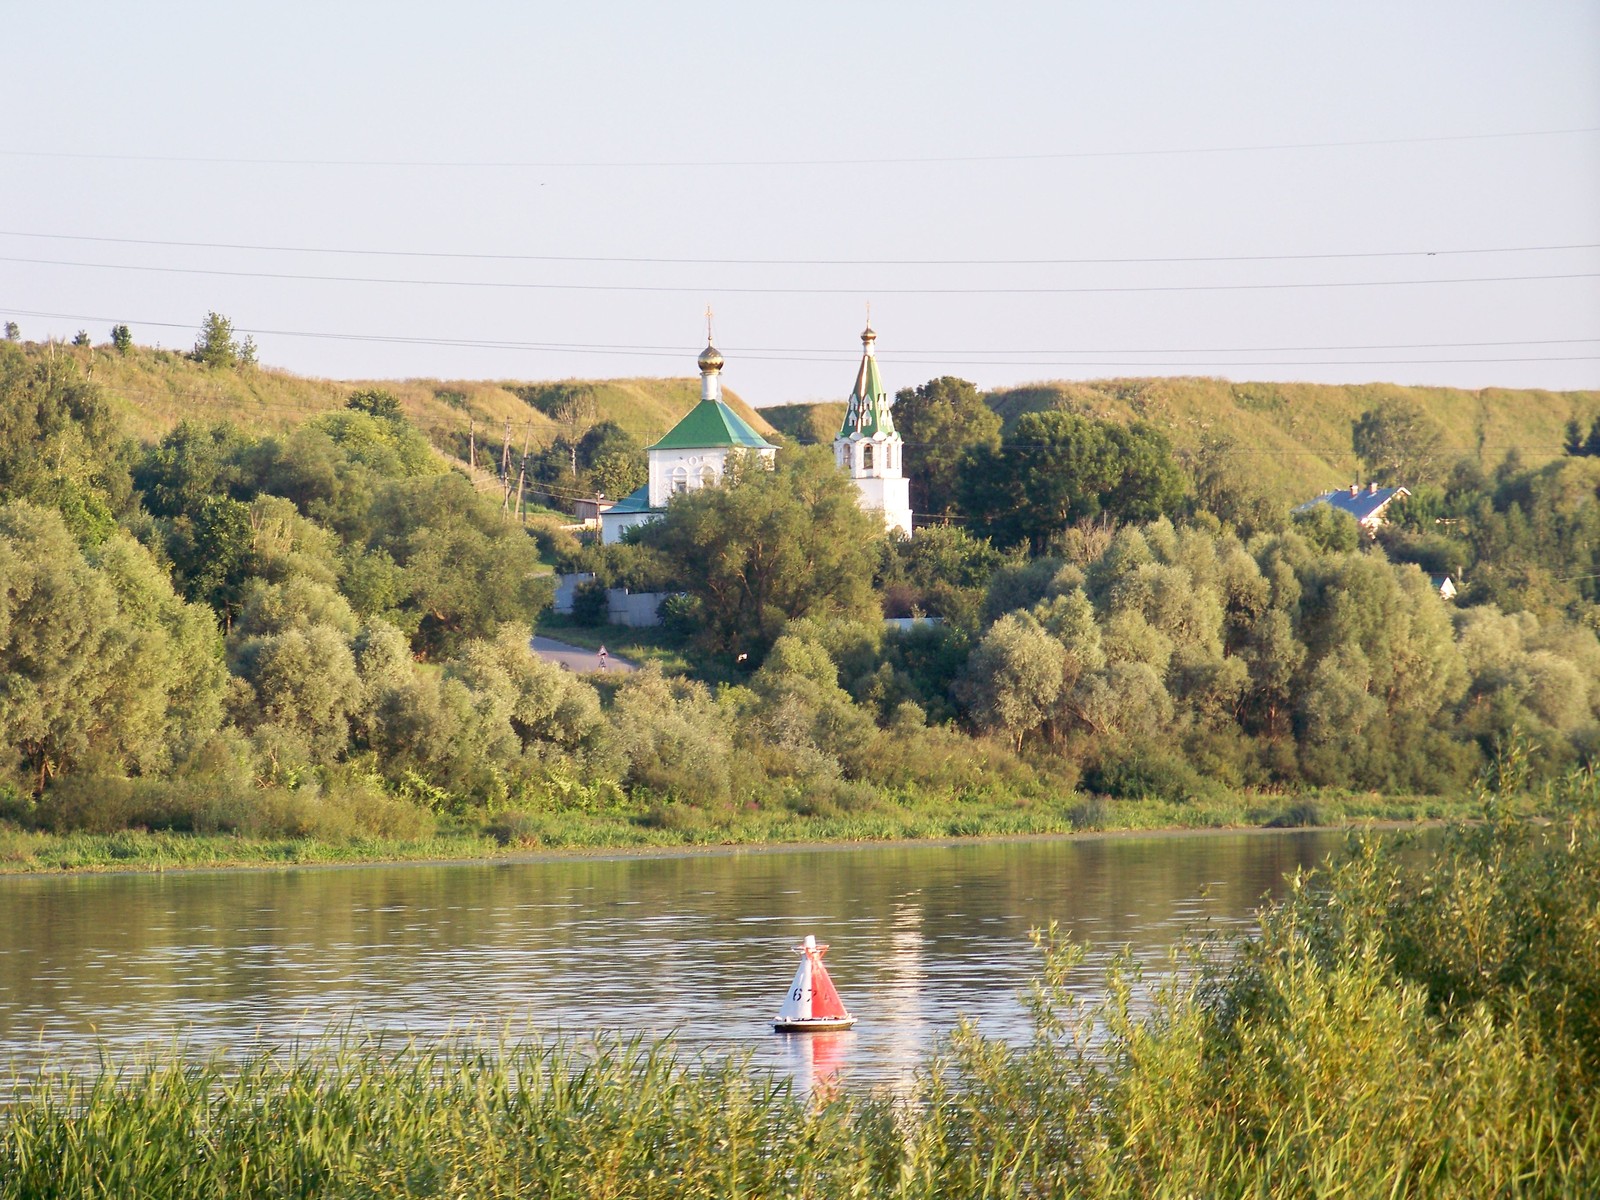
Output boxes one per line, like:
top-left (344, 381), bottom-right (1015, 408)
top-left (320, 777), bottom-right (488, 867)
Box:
top-left (600, 325), bottom-right (910, 544)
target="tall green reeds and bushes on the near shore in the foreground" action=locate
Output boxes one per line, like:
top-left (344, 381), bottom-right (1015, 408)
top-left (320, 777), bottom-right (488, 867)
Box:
top-left (9, 765), bottom-right (1600, 1197)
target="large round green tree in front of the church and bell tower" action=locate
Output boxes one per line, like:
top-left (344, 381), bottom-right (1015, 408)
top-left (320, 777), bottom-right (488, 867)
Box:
top-left (640, 446), bottom-right (883, 659)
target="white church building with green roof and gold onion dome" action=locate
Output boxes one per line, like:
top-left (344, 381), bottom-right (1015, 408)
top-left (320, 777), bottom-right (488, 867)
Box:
top-left (600, 336), bottom-right (778, 546)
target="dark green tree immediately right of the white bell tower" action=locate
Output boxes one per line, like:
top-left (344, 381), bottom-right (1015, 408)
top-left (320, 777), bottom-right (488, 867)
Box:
top-left (894, 374), bottom-right (1000, 517)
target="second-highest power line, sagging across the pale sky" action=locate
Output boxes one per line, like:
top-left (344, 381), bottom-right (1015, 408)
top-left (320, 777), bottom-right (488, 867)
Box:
top-left (0, 229), bottom-right (1600, 267)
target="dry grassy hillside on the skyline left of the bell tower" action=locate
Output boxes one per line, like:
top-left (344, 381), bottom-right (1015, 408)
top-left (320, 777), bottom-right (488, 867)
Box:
top-left (65, 346), bottom-right (773, 460)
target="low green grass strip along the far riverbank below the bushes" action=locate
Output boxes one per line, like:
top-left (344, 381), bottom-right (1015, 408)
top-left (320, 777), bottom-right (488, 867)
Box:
top-left (0, 792), bottom-right (1467, 874)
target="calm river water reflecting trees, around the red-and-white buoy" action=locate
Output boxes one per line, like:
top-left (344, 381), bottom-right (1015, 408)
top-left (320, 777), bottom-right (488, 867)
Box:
top-left (0, 832), bottom-right (1342, 1085)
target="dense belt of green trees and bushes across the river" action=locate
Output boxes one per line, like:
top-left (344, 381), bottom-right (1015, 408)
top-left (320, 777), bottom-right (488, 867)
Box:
top-left (0, 336), bottom-right (1600, 837)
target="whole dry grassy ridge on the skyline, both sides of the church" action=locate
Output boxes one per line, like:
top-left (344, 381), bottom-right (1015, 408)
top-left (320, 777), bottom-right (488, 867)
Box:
top-left (40, 346), bottom-right (1600, 501)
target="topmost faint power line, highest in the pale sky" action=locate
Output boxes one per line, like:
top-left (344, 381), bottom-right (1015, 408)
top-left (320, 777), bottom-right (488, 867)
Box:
top-left (0, 125), bottom-right (1600, 170)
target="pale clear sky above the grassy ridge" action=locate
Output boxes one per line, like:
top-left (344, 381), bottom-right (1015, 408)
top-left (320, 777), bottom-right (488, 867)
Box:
top-left (0, 0), bottom-right (1600, 405)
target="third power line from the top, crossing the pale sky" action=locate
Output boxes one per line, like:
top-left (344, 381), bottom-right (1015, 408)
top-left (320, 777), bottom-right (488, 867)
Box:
top-left (0, 254), bottom-right (1600, 296)
